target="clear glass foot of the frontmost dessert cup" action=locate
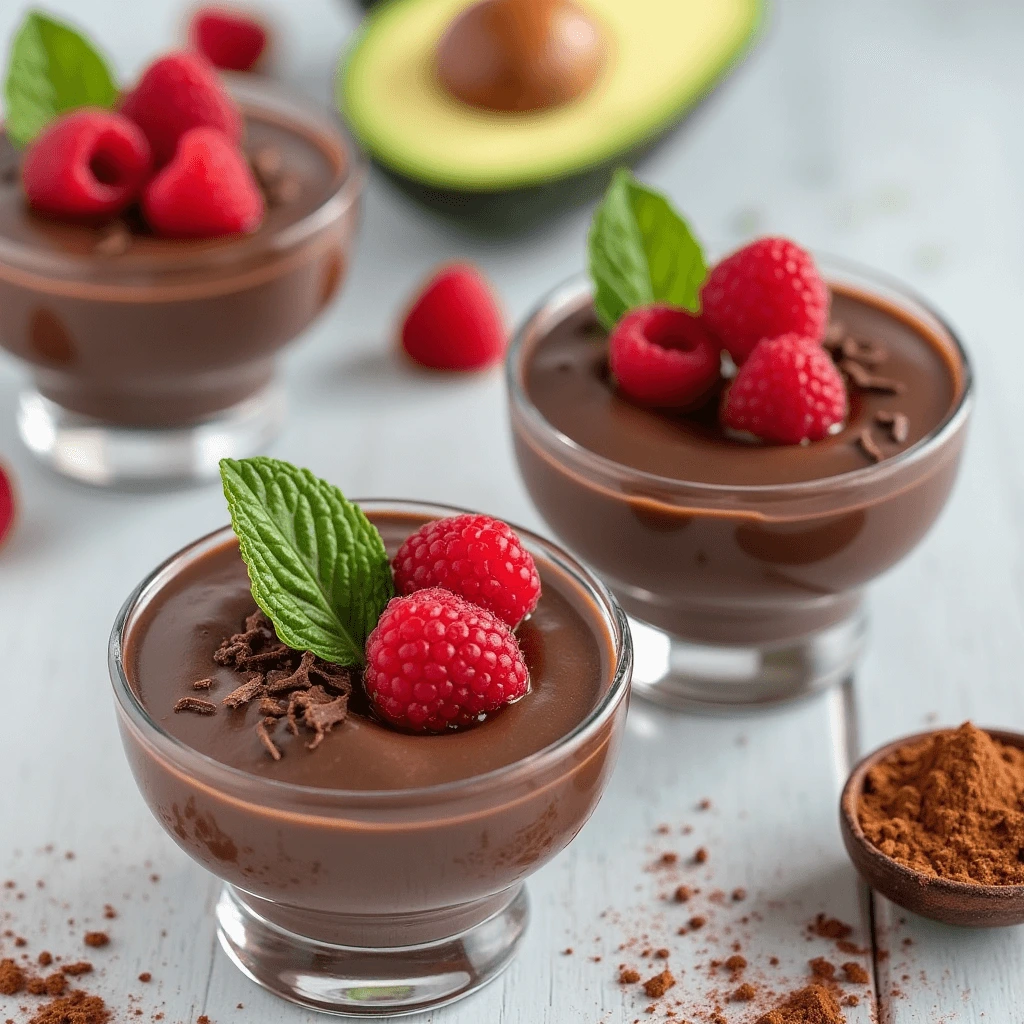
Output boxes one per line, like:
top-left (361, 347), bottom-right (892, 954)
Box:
top-left (216, 884), bottom-right (529, 1017)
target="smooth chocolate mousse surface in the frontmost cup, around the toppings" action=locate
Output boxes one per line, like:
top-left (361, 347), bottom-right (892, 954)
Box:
top-left (124, 513), bottom-right (614, 791)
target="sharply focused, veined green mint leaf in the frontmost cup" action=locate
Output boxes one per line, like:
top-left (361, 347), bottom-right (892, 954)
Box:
top-left (220, 457), bottom-right (394, 666)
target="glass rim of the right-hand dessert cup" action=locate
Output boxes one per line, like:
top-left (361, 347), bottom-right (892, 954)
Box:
top-left (505, 253), bottom-right (975, 500)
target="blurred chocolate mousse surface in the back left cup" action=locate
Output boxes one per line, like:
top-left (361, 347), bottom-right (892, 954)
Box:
top-left (0, 105), bottom-right (347, 263)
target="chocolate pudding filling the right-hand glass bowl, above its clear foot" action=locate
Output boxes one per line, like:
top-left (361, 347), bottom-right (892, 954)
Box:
top-left (509, 270), bottom-right (970, 646)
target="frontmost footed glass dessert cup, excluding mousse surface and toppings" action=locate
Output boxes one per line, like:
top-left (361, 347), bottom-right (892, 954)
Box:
top-left (110, 501), bottom-right (632, 1017)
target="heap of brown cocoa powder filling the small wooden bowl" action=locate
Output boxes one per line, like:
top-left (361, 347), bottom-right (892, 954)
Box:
top-left (857, 722), bottom-right (1024, 886)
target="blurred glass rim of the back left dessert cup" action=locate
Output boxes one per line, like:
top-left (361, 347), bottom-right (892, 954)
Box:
top-left (0, 72), bottom-right (368, 286)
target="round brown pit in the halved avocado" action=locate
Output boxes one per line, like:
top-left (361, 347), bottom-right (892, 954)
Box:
top-left (436, 0), bottom-right (607, 113)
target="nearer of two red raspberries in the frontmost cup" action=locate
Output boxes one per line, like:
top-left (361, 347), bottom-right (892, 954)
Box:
top-left (365, 587), bottom-right (529, 732)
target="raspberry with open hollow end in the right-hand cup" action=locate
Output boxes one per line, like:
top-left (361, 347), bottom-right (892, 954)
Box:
top-left (608, 305), bottom-right (722, 409)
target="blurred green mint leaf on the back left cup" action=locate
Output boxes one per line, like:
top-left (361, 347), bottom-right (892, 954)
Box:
top-left (4, 11), bottom-right (118, 145)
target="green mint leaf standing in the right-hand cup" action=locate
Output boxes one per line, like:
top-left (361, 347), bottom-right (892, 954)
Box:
top-left (589, 168), bottom-right (708, 331)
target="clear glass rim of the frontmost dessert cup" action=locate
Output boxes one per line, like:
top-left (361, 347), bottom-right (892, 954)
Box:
top-left (108, 499), bottom-right (633, 807)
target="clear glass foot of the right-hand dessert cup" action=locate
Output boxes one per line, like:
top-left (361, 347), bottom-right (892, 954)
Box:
top-left (628, 608), bottom-right (867, 712)
